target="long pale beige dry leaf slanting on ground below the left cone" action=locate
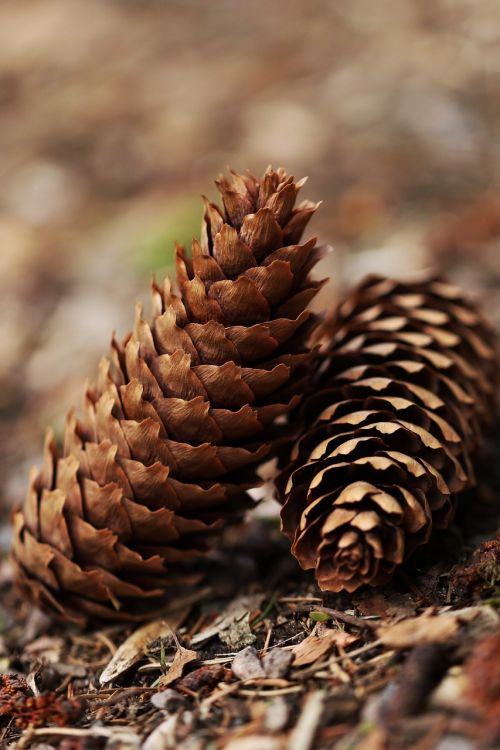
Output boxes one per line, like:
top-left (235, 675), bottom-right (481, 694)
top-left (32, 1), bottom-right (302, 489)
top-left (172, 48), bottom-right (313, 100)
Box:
top-left (99, 607), bottom-right (190, 685)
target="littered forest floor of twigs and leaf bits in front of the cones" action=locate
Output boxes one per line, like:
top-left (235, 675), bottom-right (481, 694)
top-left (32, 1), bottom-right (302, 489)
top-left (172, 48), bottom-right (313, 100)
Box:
top-left (0, 521), bottom-right (500, 750)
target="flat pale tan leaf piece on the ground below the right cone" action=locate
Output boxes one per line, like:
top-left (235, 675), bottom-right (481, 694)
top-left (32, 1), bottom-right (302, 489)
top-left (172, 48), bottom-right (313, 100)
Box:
top-left (378, 612), bottom-right (460, 648)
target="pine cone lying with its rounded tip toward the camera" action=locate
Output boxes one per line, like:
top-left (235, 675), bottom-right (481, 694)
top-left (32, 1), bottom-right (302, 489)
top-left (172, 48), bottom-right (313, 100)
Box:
top-left (278, 276), bottom-right (497, 591)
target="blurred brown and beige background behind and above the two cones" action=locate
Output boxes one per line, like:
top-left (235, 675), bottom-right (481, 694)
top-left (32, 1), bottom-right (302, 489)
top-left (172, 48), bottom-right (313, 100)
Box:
top-left (0, 0), bottom-right (500, 545)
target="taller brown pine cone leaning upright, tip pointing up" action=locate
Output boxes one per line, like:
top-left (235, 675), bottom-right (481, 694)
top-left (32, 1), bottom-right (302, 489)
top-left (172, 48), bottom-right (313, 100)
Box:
top-left (12, 169), bottom-right (321, 624)
